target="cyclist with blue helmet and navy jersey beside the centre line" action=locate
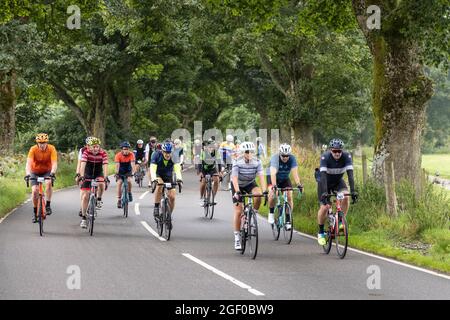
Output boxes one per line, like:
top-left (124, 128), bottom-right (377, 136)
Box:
top-left (150, 141), bottom-right (183, 219)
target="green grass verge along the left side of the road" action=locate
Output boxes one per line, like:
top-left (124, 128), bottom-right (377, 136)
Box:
top-left (0, 151), bottom-right (115, 218)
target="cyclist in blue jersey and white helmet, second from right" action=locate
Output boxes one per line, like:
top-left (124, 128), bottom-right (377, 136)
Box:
top-left (267, 143), bottom-right (303, 230)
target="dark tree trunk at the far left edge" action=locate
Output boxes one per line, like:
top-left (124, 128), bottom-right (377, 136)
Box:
top-left (0, 70), bottom-right (16, 155)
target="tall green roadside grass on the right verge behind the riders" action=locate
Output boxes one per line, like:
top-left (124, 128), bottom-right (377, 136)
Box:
top-left (259, 149), bottom-right (450, 274)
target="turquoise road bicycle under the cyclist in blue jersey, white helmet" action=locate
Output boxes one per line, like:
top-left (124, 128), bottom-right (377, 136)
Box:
top-left (272, 187), bottom-right (302, 244)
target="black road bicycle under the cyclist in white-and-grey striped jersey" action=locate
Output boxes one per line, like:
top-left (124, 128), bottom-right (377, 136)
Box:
top-left (240, 194), bottom-right (267, 259)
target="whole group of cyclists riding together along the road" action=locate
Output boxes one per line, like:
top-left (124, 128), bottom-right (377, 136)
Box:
top-left (25, 133), bottom-right (358, 250)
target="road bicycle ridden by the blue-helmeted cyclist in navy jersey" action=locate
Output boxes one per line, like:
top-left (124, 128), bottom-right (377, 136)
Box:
top-left (152, 182), bottom-right (181, 241)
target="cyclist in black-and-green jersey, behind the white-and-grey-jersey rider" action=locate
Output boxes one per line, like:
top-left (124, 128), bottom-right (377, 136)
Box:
top-left (197, 140), bottom-right (222, 207)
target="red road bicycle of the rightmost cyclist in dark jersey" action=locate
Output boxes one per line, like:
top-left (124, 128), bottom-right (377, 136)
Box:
top-left (323, 192), bottom-right (351, 259)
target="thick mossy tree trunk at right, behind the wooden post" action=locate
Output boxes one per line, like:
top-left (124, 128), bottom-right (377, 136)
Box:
top-left (372, 37), bottom-right (433, 195)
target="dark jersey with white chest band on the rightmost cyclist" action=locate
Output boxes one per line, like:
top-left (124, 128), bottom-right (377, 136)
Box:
top-left (320, 151), bottom-right (353, 186)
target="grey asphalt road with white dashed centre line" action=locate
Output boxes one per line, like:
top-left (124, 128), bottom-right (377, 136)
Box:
top-left (0, 171), bottom-right (450, 300)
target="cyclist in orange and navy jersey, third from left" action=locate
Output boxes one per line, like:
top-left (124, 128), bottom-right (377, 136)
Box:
top-left (114, 141), bottom-right (136, 209)
